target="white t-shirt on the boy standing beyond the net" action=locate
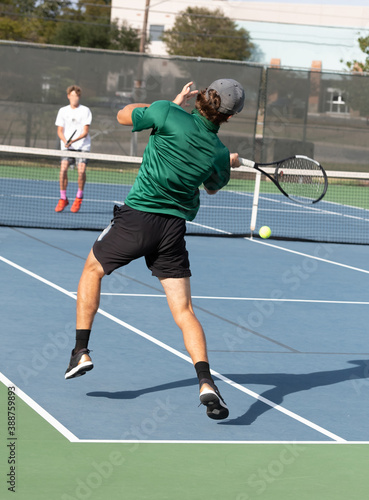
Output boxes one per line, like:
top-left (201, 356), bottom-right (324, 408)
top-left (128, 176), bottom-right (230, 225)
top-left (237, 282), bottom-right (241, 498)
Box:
top-left (55, 104), bottom-right (92, 151)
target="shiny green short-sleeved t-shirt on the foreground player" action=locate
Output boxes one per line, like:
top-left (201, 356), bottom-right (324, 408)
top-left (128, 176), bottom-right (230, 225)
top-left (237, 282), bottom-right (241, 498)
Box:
top-left (125, 101), bottom-right (230, 221)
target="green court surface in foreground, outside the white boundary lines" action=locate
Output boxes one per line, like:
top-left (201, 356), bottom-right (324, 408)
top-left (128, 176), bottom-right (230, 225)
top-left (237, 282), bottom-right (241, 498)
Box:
top-left (0, 383), bottom-right (369, 500)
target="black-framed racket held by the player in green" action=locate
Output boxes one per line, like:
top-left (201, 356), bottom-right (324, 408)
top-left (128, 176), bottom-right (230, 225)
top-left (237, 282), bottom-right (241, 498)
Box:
top-left (239, 155), bottom-right (328, 205)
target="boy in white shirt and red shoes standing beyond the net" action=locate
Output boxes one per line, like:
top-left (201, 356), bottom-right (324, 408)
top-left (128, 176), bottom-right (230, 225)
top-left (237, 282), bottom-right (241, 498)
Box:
top-left (55, 85), bottom-right (92, 212)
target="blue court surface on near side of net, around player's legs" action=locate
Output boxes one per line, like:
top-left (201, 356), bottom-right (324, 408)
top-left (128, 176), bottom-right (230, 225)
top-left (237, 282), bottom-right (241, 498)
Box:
top-left (0, 225), bottom-right (369, 442)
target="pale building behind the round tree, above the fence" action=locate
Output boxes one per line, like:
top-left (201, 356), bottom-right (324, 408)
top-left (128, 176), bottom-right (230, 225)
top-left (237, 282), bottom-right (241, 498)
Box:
top-left (111, 0), bottom-right (369, 71)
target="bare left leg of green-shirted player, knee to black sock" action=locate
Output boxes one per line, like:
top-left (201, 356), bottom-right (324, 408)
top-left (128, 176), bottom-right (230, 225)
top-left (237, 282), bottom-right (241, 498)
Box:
top-left (76, 250), bottom-right (105, 330)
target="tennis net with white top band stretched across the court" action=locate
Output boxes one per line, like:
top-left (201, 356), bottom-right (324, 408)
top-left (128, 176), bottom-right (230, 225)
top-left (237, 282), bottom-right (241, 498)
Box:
top-left (0, 146), bottom-right (369, 244)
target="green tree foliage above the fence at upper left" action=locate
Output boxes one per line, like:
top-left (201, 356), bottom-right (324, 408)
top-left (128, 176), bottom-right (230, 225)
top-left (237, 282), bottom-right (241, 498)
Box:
top-left (0, 0), bottom-right (140, 51)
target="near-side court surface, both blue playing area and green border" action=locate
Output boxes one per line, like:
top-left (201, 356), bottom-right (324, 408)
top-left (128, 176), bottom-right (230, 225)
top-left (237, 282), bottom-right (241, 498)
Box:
top-left (0, 227), bottom-right (369, 500)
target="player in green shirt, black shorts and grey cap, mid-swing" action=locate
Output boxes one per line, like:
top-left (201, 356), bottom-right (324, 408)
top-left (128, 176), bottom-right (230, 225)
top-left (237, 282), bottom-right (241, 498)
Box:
top-left (65, 79), bottom-right (245, 420)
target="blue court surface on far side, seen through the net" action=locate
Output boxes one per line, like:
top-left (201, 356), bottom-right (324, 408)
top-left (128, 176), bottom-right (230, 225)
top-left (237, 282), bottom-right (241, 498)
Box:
top-left (0, 175), bottom-right (369, 244)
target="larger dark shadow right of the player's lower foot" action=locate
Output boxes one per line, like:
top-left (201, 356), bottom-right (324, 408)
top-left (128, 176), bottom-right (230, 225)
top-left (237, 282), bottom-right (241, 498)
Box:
top-left (219, 360), bottom-right (369, 425)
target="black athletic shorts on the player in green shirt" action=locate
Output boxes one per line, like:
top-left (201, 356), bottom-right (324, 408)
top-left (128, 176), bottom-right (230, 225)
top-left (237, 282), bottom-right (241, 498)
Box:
top-left (92, 205), bottom-right (191, 278)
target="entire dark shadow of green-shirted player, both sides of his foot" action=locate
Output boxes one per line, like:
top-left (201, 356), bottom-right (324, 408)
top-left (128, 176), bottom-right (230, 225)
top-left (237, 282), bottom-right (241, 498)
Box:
top-left (87, 360), bottom-right (369, 425)
